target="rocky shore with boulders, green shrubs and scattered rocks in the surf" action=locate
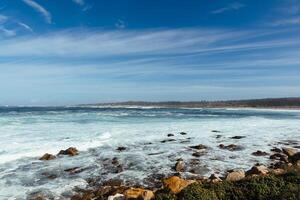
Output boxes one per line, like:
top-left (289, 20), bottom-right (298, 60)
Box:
top-left (28, 133), bottom-right (300, 200)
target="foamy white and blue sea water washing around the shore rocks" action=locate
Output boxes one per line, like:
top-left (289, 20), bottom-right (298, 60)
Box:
top-left (0, 107), bottom-right (300, 200)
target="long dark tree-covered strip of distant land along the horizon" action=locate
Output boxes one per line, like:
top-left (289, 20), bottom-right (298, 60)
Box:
top-left (81, 97), bottom-right (300, 109)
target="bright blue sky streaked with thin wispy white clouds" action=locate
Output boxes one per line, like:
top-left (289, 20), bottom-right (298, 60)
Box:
top-left (0, 0), bottom-right (300, 105)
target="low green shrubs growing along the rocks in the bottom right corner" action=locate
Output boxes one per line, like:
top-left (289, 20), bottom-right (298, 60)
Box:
top-left (155, 172), bottom-right (300, 200)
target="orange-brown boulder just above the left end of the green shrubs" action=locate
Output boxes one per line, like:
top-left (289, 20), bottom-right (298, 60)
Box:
top-left (163, 176), bottom-right (196, 194)
